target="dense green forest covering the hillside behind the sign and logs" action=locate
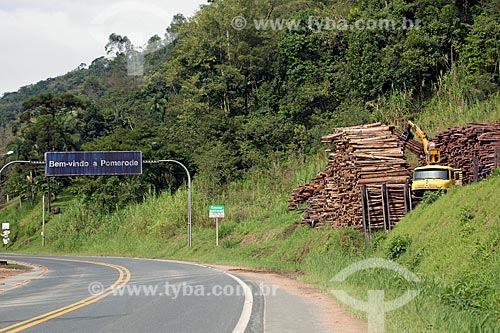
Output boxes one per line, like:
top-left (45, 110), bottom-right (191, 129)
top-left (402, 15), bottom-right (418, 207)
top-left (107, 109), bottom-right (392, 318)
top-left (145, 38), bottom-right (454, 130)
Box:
top-left (0, 0), bottom-right (500, 209)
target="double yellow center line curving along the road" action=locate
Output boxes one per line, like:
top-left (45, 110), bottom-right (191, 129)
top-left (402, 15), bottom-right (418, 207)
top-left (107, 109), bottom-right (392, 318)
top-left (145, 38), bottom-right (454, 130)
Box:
top-left (0, 258), bottom-right (131, 333)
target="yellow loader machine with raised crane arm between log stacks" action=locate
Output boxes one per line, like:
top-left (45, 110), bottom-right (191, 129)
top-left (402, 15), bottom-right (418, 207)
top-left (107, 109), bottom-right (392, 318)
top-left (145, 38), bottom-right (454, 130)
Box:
top-left (401, 120), bottom-right (462, 198)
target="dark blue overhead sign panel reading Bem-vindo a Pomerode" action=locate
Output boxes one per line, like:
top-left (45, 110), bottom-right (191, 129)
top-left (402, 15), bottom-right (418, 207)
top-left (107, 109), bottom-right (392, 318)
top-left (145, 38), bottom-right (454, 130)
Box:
top-left (45, 151), bottom-right (142, 177)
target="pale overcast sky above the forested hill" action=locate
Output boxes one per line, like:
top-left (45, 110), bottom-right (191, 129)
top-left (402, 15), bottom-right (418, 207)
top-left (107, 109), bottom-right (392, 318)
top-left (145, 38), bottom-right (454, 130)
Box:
top-left (0, 0), bottom-right (207, 96)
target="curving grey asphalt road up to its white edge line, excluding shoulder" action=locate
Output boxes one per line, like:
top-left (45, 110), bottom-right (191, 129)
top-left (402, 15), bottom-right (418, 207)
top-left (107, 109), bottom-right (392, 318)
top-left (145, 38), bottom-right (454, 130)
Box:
top-left (0, 254), bottom-right (256, 333)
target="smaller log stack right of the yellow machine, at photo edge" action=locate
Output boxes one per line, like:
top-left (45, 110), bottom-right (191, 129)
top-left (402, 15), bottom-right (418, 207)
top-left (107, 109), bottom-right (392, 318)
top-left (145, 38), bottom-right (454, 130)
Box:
top-left (433, 123), bottom-right (500, 184)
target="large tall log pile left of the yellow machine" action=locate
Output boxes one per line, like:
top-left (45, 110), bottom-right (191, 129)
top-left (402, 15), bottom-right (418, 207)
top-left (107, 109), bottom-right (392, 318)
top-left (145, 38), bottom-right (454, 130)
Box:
top-left (289, 123), bottom-right (410, 228)
